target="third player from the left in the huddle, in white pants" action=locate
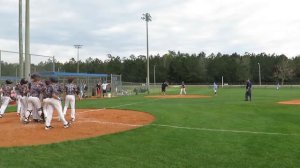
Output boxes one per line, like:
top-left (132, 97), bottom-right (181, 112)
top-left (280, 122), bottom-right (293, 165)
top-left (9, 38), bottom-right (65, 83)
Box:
top-left (24, 74), bottom-right (44, 124)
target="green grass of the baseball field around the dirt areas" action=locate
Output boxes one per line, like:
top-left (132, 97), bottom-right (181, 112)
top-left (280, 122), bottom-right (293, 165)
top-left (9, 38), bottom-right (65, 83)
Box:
top-left (0, 87), bottom-right (300, 168)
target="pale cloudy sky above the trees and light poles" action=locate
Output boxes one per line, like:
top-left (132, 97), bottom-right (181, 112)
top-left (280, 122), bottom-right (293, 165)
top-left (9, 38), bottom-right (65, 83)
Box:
top-left (0, 0), bottom-right (300, 62)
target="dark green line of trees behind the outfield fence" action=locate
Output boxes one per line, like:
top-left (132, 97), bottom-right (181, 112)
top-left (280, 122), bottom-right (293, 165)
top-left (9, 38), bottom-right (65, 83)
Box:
top-left (1, 51), bottom-right (300, 84)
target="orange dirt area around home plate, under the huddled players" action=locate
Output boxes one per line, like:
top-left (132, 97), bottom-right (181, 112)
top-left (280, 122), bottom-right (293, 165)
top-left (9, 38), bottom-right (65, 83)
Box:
top-left (0, 109), bottom-right (154, 147)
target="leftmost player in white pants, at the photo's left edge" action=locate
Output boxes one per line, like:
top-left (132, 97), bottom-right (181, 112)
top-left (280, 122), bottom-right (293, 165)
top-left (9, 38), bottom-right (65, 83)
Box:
top-left (0, 80), bottom-right (13, 118)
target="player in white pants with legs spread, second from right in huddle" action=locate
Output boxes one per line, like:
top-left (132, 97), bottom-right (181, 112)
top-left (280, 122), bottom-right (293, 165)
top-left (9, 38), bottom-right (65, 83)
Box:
top-left (43, 77), bottom-right (70, 130)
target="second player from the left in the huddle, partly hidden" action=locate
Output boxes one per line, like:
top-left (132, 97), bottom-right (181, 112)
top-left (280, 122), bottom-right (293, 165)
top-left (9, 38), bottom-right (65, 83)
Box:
top-left (17, 78), bottom-right (29, 122)
